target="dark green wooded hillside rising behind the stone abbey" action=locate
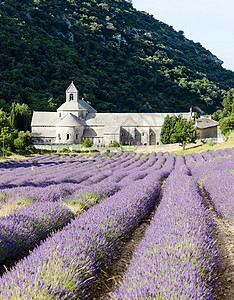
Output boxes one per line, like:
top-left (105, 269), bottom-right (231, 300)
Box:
top-left (0, 0), bottom-right (234, 112)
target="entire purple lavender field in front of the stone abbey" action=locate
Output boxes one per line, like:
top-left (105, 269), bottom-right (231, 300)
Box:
top-left (0, 148), bottom-right (234, 300)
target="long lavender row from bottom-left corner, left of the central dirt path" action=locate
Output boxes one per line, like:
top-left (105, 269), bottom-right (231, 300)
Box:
top-left (0, 157), bottom-right (174, 299)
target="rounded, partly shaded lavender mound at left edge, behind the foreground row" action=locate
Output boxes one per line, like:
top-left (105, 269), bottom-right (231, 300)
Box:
top-left (0, 202), bottom-right (75, 263)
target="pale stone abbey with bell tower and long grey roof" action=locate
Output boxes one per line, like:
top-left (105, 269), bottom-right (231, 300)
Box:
top-left (31, 82), bottom-right (195, 146)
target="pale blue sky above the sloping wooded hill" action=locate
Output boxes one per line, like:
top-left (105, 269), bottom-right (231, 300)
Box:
top-left (132, 0), bottom-right (234, 71)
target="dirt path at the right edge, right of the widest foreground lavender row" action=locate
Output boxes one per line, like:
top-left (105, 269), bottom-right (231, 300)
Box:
top-left (201, 189), bottom-right (234, 300)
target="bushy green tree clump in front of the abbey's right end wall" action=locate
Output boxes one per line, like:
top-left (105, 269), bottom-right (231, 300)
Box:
top-left (160, 115), bottom-right (196, 149)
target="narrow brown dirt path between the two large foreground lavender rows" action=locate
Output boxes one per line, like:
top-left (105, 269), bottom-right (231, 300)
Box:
top-left (90, 179), bottom-right (166, 300)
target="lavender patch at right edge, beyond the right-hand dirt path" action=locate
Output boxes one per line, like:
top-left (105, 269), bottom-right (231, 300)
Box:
top-left (187, 148), bottom-right (234, 224)
